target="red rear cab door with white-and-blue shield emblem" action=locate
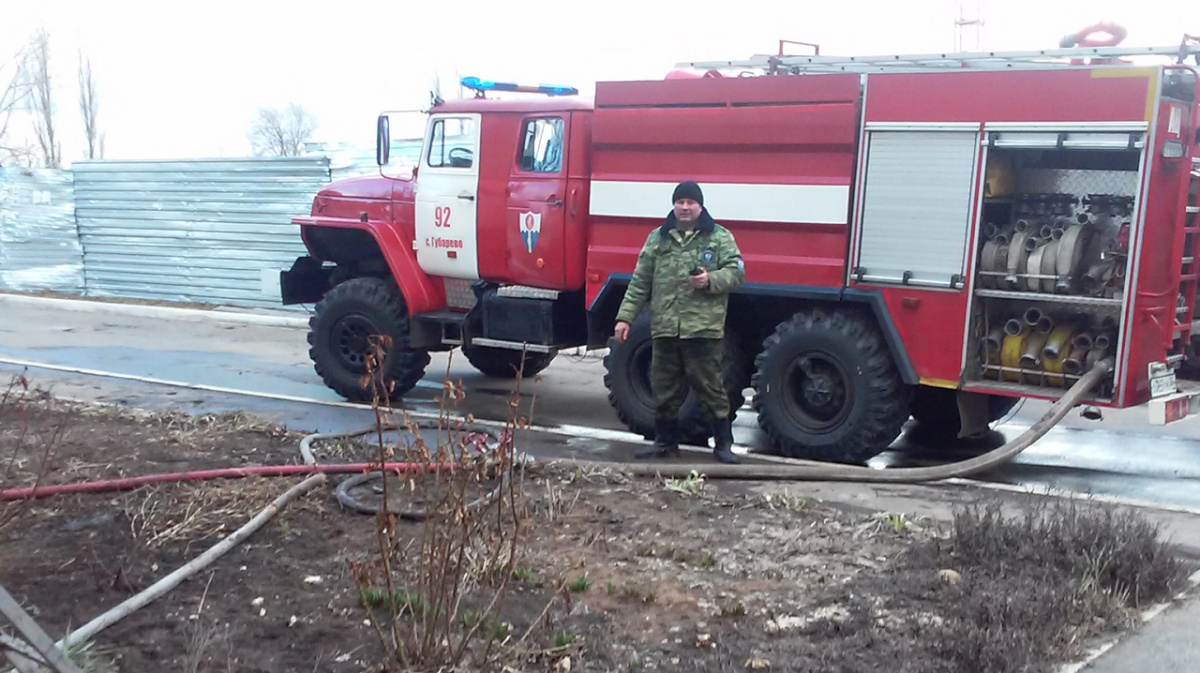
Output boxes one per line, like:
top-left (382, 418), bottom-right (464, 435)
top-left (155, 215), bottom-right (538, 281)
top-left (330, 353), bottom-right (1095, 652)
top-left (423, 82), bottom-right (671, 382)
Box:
top-left (504, 113), bottom-right (570, 289)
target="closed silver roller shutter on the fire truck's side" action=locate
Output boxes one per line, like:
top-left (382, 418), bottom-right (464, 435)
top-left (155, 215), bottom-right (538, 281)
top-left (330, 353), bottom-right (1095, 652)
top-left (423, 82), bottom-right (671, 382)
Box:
top-left (854, 131), bottom-right (979, 288)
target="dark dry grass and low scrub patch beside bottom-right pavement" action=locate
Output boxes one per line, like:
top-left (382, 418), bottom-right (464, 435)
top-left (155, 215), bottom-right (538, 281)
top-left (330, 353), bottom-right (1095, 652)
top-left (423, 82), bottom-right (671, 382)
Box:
top-left (768, 503), bottom-right (1190, 673)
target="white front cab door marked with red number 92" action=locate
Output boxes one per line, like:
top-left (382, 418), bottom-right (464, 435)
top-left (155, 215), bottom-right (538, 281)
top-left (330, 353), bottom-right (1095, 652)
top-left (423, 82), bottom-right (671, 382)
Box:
top-left (413, 114), bottom-right (480, 280)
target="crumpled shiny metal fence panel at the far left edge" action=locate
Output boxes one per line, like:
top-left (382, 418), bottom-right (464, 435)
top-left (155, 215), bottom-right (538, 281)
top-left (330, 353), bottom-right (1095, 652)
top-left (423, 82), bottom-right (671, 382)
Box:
top-left (0, 168), bottom-right (83, 294)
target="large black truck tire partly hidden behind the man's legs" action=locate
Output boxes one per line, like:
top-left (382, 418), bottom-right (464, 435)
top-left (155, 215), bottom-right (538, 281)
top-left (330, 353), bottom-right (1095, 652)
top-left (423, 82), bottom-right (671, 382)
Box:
top-left (604, 313), bottom-right (750, 446)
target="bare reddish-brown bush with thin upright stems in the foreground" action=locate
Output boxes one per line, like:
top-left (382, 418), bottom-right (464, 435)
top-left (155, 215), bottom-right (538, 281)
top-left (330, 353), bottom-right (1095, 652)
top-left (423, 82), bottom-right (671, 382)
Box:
top-left (352, 337), bottom-right (527, 669)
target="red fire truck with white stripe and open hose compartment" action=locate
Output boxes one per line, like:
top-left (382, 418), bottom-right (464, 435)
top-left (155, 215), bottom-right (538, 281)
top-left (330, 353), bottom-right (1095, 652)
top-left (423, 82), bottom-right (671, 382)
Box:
top-left (281, 43), bottom-right (1200, 461)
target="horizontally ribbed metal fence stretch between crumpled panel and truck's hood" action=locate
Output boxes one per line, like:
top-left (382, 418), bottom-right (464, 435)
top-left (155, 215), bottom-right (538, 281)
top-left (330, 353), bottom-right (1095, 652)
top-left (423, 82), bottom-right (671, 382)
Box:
top-left (73, 157), bottom-right (329, 307)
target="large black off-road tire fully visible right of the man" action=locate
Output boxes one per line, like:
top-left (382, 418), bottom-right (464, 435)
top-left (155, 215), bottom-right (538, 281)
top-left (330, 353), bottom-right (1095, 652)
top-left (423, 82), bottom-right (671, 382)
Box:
top-left (754, 308), bottom-right (908, 463)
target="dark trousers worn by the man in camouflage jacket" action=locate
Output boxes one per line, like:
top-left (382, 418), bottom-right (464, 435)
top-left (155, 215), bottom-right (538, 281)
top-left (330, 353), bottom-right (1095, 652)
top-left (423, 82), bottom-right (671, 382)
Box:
top-left (650, 337), bottom-right (730, 421)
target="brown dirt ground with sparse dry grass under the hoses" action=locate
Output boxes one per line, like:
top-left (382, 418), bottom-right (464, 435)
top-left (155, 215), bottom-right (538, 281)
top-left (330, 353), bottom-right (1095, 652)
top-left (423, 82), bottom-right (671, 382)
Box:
top-left (0, 390), bottom-right (1186, 673)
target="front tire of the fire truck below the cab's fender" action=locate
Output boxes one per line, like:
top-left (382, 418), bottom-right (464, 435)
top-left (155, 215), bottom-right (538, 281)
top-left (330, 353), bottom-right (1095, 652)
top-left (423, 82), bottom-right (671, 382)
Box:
top-left (308, 278), bottom-right (430, 402)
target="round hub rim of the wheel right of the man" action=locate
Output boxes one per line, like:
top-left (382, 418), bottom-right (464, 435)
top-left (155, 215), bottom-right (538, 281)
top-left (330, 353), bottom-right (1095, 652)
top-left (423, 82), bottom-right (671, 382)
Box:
top-left (781, 353), bottom-right (854, 432)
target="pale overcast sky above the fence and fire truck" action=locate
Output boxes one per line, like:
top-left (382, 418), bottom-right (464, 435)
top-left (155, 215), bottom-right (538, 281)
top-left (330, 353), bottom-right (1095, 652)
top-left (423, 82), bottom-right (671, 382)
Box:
top-left (0, 0), bottom-right (1200, 161)
